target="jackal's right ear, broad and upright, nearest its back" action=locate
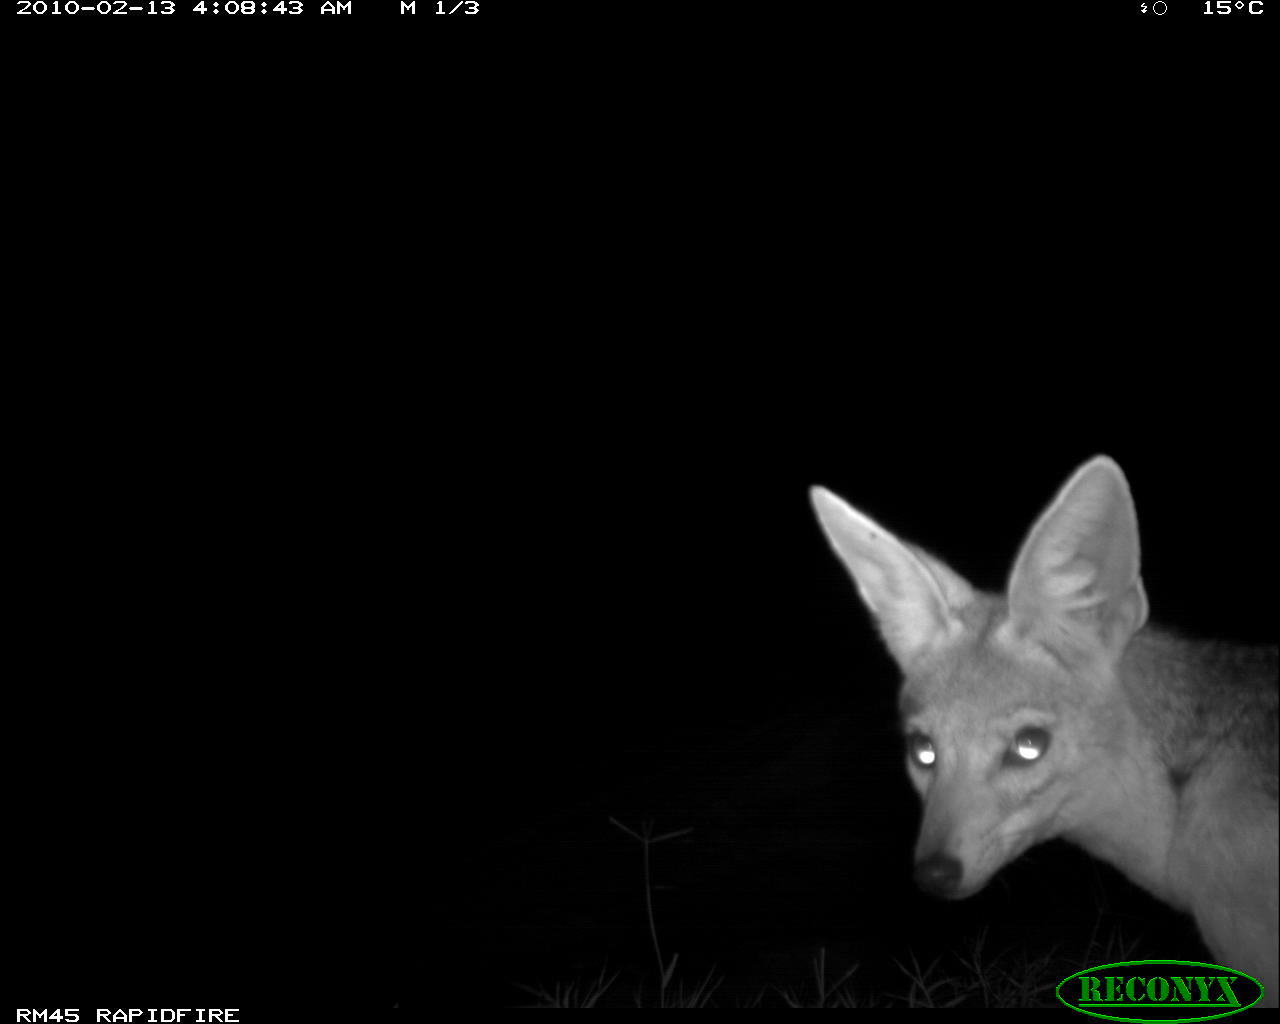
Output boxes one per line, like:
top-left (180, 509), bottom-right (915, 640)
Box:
top-left (1009, 456), bottom-right (1147, 654)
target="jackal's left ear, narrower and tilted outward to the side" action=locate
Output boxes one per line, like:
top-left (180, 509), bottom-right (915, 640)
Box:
top-left (809, 488), bottom-right (973, 664)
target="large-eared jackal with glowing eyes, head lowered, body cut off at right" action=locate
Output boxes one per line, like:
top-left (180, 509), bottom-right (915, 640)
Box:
top-left (810, 456), bottom-right (1280, 1005)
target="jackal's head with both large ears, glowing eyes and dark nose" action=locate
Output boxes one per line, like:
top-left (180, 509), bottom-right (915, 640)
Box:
top-left (812, 456), bottom-right (1147, 899)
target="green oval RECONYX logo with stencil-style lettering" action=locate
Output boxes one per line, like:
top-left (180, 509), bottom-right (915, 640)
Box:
top-left (1057, 960), bottom-right (1262, 1024)
